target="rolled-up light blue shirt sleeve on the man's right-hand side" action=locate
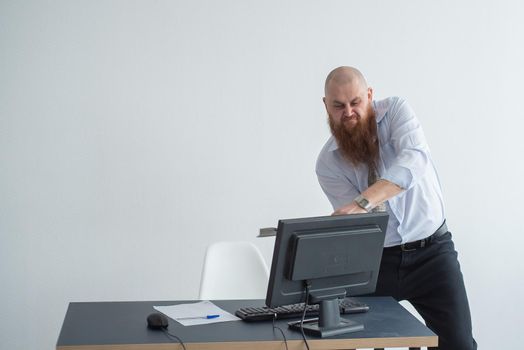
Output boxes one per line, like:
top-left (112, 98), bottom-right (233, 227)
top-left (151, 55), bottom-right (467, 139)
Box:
top-left (382, 99), bottom-right (429, 190)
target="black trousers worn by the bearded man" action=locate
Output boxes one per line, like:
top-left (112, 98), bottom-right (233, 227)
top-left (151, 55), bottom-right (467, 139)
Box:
top-left (374, 232), bottom-right (477, 350)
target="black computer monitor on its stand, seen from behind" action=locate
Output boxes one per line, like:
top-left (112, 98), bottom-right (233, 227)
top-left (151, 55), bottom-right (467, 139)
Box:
top-left (266, 213), bottom-right (388, 337)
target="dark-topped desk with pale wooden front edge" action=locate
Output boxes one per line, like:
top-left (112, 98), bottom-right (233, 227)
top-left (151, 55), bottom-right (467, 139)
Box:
top-left (56, 297), bottom-right (438, 350)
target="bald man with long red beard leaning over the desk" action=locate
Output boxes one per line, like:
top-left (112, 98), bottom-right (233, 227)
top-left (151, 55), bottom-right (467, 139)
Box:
top-left (316, 67), bottom-right (477, 350)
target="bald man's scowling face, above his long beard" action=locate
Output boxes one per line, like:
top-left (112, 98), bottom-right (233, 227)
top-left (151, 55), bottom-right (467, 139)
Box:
top-left (324, 82), bottom-right (373, 133)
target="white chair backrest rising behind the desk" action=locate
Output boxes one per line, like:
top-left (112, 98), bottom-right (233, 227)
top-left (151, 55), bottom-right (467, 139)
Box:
top-left (198, 242), bottom-right (269, 300)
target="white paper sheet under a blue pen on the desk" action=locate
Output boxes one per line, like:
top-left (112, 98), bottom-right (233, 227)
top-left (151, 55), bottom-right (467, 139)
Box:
top-left (153, 300), bottom-right (240, 326)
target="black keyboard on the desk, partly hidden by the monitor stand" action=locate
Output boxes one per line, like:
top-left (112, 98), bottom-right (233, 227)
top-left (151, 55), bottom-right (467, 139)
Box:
top-left (235, 298), bottom-right (369, 322)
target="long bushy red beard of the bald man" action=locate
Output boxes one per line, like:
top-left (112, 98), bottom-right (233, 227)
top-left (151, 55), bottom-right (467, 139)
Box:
top-left (328, 106), bottom-right (379, 167)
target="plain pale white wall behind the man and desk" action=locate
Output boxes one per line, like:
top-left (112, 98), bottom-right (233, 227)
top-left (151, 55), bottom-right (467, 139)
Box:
top-left (0, 0), bottom-right (524, 349)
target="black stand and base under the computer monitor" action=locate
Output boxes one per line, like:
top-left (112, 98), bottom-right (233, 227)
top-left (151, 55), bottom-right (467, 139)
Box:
top-left (289, 298), bottom-right (364, 338)
